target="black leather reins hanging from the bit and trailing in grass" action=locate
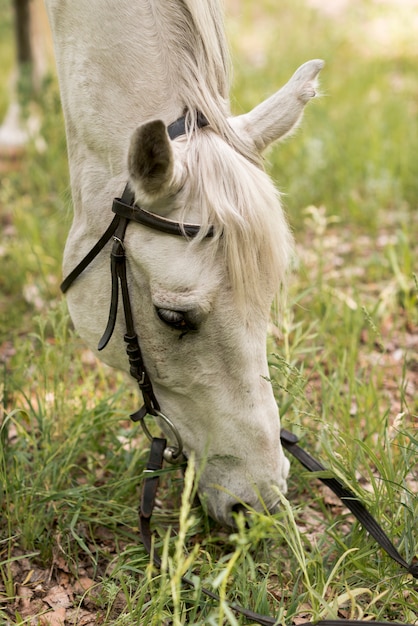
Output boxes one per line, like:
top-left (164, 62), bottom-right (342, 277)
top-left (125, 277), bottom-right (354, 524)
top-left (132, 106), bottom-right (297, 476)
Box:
top-left (139, 429), bottom-right (418, 626)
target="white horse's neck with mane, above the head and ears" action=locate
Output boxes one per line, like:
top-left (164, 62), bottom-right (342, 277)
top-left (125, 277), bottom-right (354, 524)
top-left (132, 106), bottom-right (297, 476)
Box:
top-left (47, 0), bottom-right (233, 224)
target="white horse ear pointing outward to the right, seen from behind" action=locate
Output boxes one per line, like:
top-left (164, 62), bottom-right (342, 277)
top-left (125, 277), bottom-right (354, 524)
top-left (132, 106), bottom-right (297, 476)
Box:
top-left (230, 59), bottom-right (324, 153)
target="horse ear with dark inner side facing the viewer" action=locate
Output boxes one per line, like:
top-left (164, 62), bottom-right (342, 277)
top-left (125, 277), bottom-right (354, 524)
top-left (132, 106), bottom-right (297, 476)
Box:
top-left (128, 120), bottom-right (179, 201)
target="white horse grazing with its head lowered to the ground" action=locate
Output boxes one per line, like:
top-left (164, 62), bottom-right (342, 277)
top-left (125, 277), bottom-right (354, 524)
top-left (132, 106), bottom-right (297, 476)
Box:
top-left (46, 0), bottom-right (323, 524)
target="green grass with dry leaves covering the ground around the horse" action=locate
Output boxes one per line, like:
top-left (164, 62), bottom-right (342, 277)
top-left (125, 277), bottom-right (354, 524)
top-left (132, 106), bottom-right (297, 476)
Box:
top-left (0, 0), bottom-right (418, 626)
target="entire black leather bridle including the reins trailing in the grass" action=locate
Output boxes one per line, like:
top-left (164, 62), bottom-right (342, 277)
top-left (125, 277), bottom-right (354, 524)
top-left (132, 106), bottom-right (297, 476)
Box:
top-left (61, 113), bottom-right (418, 626)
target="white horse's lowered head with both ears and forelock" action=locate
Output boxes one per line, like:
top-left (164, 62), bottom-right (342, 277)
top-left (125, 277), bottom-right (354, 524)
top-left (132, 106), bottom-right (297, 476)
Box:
top-left (121, 61), bottom-right (323, 524)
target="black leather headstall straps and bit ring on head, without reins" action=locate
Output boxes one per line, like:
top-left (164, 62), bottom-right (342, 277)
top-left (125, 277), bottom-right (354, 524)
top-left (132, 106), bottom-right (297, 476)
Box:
top-left (61, 113), bottom-right (214, 463)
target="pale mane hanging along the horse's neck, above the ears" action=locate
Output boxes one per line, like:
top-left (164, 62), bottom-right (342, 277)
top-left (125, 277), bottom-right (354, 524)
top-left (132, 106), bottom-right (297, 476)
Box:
top-left (149, 0), bottom-right (255, 157)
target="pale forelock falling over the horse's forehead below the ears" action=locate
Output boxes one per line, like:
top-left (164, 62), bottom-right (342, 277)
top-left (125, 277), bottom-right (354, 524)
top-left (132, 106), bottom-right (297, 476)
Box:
top-left (182, 128), bottom-right (293, 307)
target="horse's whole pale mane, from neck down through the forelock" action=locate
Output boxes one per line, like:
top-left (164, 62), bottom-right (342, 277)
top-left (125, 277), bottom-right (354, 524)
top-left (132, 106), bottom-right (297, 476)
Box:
top-left (150, 0), bottom-right (292, 302)
